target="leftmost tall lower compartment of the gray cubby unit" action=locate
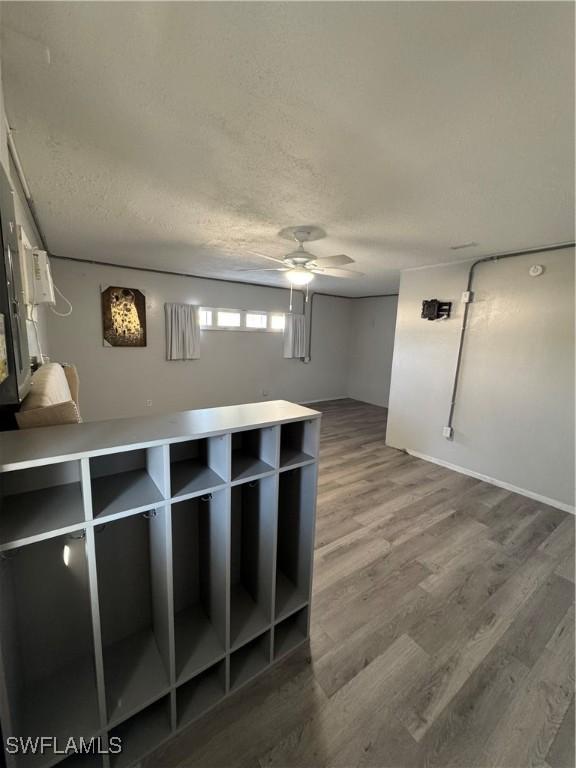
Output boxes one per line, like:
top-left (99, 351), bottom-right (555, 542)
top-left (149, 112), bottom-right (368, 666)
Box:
top-left (0, 532), bottom-right (101, 766)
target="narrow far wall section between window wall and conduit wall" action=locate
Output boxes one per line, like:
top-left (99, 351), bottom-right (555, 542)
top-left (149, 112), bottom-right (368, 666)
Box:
top-left (348, 296), bottom-right (398, 408)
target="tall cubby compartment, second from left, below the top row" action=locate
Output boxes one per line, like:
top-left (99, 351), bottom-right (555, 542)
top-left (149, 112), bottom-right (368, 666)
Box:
top-left (95, 507), bottom-right (170, 723)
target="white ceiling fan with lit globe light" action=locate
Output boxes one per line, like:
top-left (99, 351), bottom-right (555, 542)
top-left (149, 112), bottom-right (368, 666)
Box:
top-left (239, 226), bottom-right (363, 286)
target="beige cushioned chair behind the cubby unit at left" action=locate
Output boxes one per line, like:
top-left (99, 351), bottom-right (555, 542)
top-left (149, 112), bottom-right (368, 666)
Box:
top-left (16, 363), bottom-right (82, 429)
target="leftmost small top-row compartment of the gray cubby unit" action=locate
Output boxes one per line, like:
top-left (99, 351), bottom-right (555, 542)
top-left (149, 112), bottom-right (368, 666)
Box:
top-left (0, 461), bottom-right (84, 551)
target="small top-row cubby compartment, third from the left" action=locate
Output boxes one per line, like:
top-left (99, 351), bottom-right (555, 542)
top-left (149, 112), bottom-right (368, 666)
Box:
top-left (170, 435), bottom-right (229, 497)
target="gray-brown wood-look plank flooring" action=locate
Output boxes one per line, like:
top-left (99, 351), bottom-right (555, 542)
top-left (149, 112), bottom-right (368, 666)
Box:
top-left (145, 400), bottom-right (575, 768)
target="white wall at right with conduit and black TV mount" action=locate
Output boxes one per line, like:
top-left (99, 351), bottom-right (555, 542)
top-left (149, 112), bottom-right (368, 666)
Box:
top-left (387, 249), bottom-right (574, 506)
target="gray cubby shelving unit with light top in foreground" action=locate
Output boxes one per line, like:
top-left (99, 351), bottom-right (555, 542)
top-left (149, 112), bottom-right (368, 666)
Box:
top-left (0, 401), bottom-right (320, 768)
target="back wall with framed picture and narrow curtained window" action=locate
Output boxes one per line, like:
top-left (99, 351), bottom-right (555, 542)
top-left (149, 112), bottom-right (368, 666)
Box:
top-left (47, 259), bottom-right (351, 420)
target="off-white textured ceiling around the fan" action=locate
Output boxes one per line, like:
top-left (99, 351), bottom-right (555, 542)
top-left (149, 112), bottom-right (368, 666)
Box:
top-left (2, 2), bottom-right (574, 295)
